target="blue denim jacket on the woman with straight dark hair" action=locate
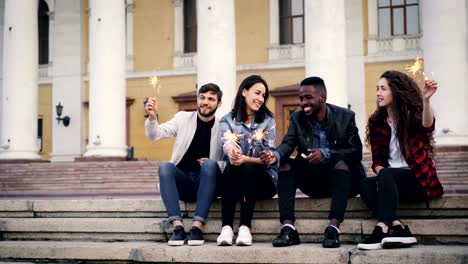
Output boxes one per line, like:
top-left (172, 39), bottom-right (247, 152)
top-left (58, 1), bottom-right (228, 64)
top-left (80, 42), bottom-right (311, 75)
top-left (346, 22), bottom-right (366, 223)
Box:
top-left (219, 112), bottom-right (279, 187)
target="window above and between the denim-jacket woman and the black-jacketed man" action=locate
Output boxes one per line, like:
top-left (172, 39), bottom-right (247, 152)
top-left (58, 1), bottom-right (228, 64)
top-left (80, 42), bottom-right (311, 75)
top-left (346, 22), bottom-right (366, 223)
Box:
top-left (279, 0), bottom-right (304, 45)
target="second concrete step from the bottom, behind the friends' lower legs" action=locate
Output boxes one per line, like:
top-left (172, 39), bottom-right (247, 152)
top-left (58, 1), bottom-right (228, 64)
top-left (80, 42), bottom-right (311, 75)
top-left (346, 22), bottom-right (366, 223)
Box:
top-left (0, 218), bottom-right (468, 244)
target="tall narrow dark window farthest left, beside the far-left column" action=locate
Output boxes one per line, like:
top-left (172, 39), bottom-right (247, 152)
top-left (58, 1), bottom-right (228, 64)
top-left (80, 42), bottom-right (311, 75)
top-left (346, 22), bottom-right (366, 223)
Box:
top-left (37, 0), bottom-right (49, 64)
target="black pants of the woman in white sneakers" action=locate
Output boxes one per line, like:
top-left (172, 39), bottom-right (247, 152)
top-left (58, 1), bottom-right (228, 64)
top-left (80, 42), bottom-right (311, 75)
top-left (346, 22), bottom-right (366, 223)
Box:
top-left (221, 163), bottom-right (276, 228)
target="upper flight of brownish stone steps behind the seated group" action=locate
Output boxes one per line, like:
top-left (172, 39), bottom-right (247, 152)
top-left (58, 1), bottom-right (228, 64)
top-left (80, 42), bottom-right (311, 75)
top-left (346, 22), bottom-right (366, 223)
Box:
top-left (0, 150), bottom-right (468, 197)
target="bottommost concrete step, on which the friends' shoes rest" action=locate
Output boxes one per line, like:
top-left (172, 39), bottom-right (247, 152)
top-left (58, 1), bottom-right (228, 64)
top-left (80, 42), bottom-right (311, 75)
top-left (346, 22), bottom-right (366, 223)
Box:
top-left (0, 241), bottom-right (468, 264)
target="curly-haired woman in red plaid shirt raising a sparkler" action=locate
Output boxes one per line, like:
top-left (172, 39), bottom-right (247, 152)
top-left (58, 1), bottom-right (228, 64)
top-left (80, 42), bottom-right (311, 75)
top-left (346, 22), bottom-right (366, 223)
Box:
top-left (358, 71), bottom-right (443, 249)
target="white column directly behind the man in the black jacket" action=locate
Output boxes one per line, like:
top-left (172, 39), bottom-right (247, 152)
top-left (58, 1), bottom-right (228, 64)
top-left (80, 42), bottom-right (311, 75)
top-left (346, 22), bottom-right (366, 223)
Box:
top-left (304, 0), bottom-right (348, 107)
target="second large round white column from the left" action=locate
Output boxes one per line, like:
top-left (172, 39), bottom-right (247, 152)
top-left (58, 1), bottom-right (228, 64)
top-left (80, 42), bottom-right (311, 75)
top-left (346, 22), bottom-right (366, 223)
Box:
top-left (85, 0), bottom-right (126, 157)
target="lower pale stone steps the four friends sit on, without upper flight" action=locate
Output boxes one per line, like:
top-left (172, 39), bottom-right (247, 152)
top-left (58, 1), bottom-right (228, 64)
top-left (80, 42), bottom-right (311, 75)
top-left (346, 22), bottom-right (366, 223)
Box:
top-left (0, 194), bottom-right (468, 263)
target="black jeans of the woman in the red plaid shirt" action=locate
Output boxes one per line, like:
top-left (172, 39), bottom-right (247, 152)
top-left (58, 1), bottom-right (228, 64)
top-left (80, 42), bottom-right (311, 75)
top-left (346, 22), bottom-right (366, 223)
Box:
top-left (360, 168), bottom-right (427, 225)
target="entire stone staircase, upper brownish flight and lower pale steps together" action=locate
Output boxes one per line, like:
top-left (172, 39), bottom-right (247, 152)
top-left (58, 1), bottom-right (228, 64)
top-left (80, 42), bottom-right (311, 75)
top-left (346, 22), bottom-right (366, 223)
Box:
top-left (0, 150), bottom-right (468, 264)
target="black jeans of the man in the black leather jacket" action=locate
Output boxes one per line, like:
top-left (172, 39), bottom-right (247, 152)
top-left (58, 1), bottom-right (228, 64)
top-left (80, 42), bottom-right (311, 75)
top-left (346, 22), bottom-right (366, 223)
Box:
top-left (278, 158), bottom-right (356, 223)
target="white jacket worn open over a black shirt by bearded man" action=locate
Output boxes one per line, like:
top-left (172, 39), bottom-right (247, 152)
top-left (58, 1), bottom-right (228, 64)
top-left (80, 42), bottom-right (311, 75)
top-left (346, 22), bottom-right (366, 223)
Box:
top-left (145, 111), bottom-right (226, 171)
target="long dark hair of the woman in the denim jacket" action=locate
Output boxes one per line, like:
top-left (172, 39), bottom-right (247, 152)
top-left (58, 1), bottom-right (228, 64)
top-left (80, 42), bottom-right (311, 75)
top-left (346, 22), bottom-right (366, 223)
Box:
top-left (232, 75), bottom-right (273, 123)
